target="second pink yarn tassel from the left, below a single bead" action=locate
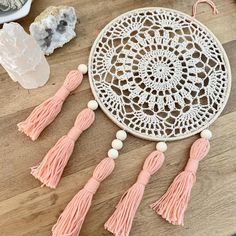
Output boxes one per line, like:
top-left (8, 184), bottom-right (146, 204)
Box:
top-left (31, 108), bottom-right (95, 188)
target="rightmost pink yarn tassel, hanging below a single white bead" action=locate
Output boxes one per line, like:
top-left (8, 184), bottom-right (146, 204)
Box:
top-left (151, 138), bottom-right (210, 225)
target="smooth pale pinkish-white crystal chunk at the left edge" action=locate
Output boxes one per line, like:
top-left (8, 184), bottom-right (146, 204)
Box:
top-left (0, 22), bottom-right (50, 89)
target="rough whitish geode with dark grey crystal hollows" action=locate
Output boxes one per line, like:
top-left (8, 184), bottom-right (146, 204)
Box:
top-left (30, 6), bottom-right (77, 55)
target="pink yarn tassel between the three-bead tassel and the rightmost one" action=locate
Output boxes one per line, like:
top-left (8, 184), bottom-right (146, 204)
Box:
top-left (105, 151), bottom-right (165, 236)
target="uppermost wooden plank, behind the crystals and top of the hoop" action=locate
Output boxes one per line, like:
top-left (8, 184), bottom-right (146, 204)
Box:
top-left (0, 0), bottom-right (236, 116)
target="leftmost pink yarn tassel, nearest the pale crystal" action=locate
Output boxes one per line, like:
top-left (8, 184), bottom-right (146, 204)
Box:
top-left (17, 70), bottom-right (83, 141)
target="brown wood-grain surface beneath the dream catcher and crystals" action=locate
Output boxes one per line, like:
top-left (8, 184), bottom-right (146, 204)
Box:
top-left (0, 0), bottom-right (236, 236)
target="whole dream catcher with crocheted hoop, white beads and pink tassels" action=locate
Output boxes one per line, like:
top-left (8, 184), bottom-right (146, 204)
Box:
top-left (18, 1), bottom-right (231, 236)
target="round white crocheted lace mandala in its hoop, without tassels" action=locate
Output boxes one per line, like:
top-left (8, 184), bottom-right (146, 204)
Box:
top-left (89, 8), bottom-right (231, 141)
